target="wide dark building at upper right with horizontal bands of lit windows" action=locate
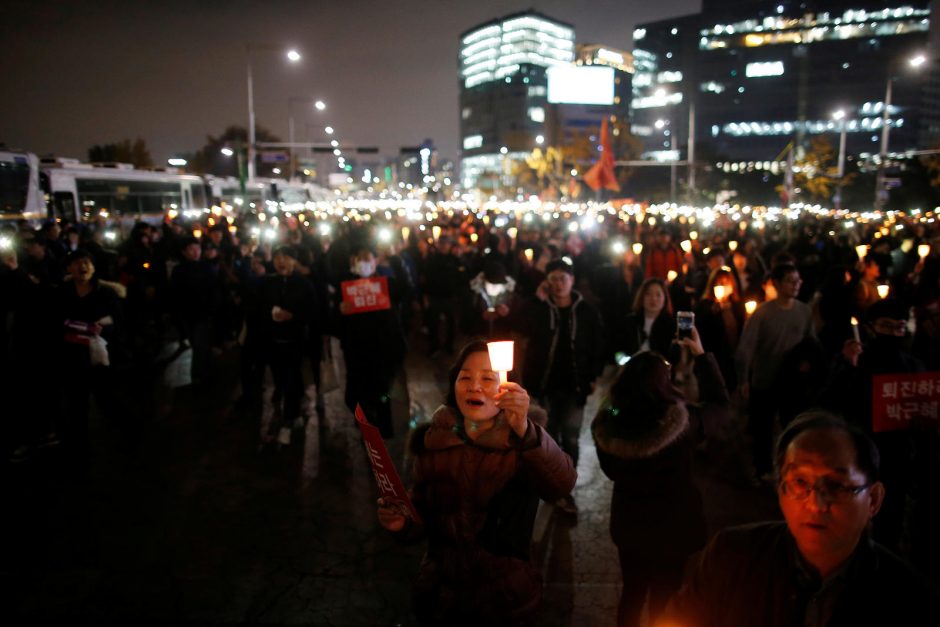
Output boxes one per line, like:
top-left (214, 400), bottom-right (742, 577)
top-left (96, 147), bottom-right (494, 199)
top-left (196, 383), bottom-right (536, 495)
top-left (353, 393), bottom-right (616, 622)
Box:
top-left (631, 0), bottom-right (940, 173)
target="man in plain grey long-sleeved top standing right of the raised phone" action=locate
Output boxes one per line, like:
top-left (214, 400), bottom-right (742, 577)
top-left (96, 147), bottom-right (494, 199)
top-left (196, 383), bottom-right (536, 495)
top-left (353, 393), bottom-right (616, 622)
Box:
top-left (735, 263), bottom-right (815, 483)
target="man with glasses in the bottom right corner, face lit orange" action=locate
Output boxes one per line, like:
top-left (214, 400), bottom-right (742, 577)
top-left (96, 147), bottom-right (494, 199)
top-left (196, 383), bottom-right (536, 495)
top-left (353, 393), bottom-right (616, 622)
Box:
top-left (658, 412), bottom-right (938, 627)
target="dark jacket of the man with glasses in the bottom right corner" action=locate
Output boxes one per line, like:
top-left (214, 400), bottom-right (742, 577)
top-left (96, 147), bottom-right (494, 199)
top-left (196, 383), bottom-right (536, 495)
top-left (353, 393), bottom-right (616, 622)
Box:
top-left (666, 522), bottom-right (937, 627)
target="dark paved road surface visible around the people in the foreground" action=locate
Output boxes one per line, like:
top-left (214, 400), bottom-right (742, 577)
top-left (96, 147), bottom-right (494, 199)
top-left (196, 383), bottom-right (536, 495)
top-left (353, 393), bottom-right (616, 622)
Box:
top-left (0, 340), bottom-right (776, 626)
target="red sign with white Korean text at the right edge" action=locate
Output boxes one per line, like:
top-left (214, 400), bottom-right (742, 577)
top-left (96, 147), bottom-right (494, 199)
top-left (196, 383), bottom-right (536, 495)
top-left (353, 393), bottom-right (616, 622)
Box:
top-left (871, 372), bottom-right (940, 433)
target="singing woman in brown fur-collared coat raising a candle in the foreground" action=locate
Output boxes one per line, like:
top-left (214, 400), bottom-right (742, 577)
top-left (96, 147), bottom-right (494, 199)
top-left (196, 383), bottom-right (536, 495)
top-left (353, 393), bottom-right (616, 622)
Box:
top-left (379, 342), bottom-right (577, 625)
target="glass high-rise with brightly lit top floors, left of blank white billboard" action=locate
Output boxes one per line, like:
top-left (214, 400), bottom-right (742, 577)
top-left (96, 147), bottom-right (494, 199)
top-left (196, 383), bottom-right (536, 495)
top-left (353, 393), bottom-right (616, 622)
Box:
top-left (459, 11), bottom-right (575, 189)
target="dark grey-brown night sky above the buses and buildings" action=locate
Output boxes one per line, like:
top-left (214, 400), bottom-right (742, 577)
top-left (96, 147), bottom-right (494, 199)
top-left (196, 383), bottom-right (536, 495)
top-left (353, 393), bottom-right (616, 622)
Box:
top-left (0, 0), bottom-right (700, 163)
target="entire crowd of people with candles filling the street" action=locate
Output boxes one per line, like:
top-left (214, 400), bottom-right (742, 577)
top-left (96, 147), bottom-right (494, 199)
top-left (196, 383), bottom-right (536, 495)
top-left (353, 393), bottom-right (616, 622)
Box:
top-left (0, 204), bottom-right (940, 625)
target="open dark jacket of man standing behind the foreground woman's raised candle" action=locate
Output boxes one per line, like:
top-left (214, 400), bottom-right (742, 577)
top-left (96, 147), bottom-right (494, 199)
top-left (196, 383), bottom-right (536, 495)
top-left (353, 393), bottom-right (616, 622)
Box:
top-left (521, 291), bottom-right (605, 403)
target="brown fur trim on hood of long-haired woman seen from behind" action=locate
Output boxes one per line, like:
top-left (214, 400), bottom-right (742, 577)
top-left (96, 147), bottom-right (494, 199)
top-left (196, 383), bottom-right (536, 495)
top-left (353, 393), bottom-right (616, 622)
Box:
top-left (591, 402), bottom-right (689, 459)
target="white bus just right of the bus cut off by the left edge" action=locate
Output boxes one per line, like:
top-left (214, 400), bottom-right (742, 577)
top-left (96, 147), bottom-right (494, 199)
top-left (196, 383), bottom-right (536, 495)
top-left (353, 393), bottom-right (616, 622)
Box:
top-left (39, 159), bottom-right (209, 228)
